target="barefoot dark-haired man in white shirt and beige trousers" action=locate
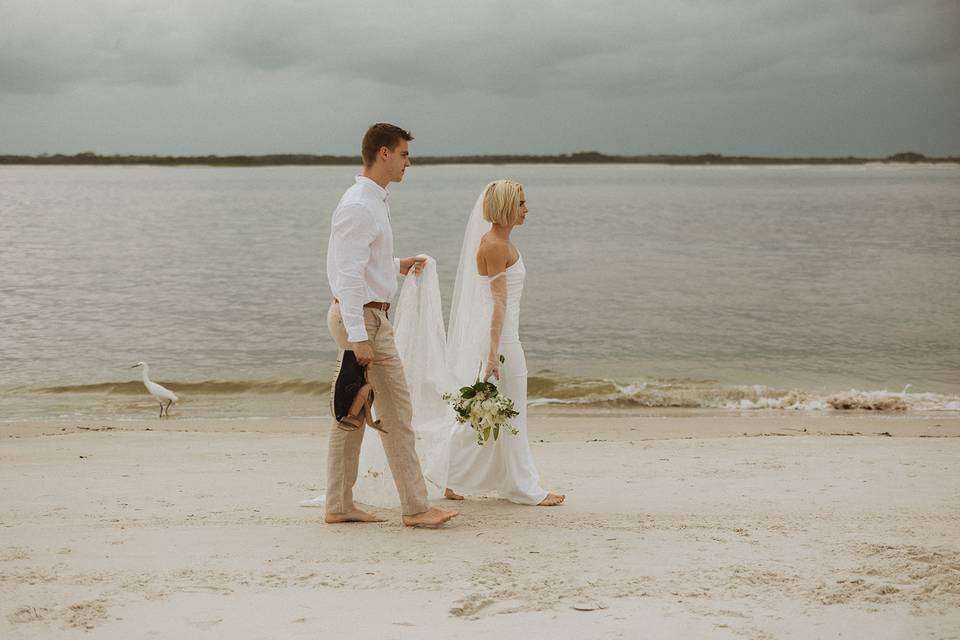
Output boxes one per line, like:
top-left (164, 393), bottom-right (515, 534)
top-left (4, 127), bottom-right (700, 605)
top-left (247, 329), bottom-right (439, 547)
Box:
top-left (324, 123), bottom-right (457, 527)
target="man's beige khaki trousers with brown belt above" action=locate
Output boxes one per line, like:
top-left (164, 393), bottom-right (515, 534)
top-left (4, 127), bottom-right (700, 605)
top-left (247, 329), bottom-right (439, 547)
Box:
top-left (326, 302), bottom-right (430, 515)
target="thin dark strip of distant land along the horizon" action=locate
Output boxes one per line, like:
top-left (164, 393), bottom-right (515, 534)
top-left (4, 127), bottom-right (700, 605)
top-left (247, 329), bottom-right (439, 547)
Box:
top-left (0, 151), bottom-right (960, 167)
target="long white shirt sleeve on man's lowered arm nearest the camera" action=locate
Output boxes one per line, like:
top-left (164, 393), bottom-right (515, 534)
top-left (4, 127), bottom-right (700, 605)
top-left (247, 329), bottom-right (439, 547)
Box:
top-left (330, 204), bottom-right (377, 342)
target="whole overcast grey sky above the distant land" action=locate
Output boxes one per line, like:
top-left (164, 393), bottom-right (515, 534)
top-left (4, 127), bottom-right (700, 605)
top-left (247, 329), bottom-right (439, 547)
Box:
top-left (0, 0), bottom-right (960, 156)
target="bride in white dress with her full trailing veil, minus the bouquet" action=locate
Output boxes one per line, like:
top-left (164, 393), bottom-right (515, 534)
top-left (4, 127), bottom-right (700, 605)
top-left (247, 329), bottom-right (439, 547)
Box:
top-left (338, 180), bottom-right (565, 507)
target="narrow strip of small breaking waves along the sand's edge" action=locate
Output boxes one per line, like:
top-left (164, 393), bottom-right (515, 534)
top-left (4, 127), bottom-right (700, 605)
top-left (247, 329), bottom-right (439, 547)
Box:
top-left (7, 376), bottom-right (960, 428)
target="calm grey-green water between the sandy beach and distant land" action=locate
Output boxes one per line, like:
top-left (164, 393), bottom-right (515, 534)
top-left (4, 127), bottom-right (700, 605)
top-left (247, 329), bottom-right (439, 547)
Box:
top-left (0, 165), bottom-right (960, 419)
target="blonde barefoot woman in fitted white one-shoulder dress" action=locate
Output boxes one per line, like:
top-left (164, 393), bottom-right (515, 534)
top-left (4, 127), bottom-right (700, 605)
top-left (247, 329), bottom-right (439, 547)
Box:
top-left (444, 180), bottom-right (565, 506)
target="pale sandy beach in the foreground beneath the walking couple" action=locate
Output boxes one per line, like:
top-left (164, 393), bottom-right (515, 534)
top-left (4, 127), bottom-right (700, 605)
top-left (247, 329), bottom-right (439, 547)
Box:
top-left (0, 409), bottom-right (960, 640)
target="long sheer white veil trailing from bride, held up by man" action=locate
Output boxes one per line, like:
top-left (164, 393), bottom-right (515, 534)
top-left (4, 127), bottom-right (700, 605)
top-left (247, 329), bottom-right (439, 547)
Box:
top-left (300, 188), bottom-right (491, 507)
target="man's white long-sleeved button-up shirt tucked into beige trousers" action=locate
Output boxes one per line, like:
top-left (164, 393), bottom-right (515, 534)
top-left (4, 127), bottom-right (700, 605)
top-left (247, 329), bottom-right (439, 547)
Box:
top-left (327, 176), bottom-right (400, 342)
